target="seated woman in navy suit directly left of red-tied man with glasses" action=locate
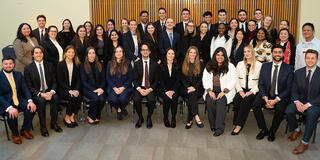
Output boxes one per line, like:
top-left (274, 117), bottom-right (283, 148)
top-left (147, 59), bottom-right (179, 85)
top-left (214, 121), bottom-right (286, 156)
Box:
top-left (106, 45), bottom-right (133, 120)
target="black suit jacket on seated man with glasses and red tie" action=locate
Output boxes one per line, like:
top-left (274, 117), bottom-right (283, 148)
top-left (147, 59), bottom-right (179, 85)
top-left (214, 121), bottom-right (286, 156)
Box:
top-left (133, 58), bottom-right (159, 91)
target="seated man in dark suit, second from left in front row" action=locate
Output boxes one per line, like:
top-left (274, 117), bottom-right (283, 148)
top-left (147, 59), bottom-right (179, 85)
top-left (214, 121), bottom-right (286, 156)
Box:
top-left (24, 46), bottom-right (62, 137)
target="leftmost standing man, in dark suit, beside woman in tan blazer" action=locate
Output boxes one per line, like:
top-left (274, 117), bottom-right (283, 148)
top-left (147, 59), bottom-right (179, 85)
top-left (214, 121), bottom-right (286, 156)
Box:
top-left (32, 15), bottom-right (48, 44)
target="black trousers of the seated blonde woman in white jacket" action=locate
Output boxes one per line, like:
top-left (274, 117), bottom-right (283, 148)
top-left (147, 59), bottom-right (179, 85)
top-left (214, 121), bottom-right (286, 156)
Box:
top-left (233, 93), bottom-right (256, 127)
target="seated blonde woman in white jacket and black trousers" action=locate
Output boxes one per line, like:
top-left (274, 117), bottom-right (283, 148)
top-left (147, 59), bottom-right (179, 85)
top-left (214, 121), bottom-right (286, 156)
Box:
top-left (231, 45), bottom-right (262, 135)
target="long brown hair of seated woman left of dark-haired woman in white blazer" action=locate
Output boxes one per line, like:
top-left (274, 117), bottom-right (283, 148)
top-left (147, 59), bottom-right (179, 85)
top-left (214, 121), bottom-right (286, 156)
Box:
top-left (182, 46), bottom-right (201, 76)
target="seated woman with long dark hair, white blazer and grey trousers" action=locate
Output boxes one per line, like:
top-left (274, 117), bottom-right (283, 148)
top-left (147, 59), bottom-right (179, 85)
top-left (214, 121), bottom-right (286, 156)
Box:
top-left (202, 47), bottom-right (237, 136)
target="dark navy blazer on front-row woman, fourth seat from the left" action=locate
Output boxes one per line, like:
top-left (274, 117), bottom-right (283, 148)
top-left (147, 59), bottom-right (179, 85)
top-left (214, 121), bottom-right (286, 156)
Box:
top-left (80, 64), bottom-right (106, 95)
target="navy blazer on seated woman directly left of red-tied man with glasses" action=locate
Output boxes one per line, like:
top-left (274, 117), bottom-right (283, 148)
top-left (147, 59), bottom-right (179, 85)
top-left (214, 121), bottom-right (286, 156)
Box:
top-left (106, 61), bottom-right (133, 93)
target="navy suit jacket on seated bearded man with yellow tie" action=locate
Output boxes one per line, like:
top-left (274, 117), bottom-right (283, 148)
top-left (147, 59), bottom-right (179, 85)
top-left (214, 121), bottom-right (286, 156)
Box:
top-left (0, 69), bottom-right (32, 115)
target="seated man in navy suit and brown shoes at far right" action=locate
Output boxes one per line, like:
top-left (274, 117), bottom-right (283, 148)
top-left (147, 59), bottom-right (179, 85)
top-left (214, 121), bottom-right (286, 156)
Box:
top-left (286, 49), bottom-right (320, 154)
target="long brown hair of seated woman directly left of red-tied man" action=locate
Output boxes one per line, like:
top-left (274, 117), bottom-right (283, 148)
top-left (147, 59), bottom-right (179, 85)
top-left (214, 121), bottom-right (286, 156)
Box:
top-left (110, 46), bottom-right (128, 76)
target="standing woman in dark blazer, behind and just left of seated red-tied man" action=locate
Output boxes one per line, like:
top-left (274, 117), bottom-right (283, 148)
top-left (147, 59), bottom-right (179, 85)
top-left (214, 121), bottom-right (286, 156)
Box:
top-left (122, 19), bottom-right (141, 61)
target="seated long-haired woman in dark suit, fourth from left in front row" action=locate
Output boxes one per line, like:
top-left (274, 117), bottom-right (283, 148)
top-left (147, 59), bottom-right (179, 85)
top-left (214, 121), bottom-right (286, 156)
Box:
top-left (80, 47), bottom-right (106, 125)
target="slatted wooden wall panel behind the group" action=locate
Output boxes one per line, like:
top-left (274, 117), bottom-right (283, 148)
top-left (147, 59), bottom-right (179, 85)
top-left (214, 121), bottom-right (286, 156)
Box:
top-left (91, 0), bottom-right (299, 38)
